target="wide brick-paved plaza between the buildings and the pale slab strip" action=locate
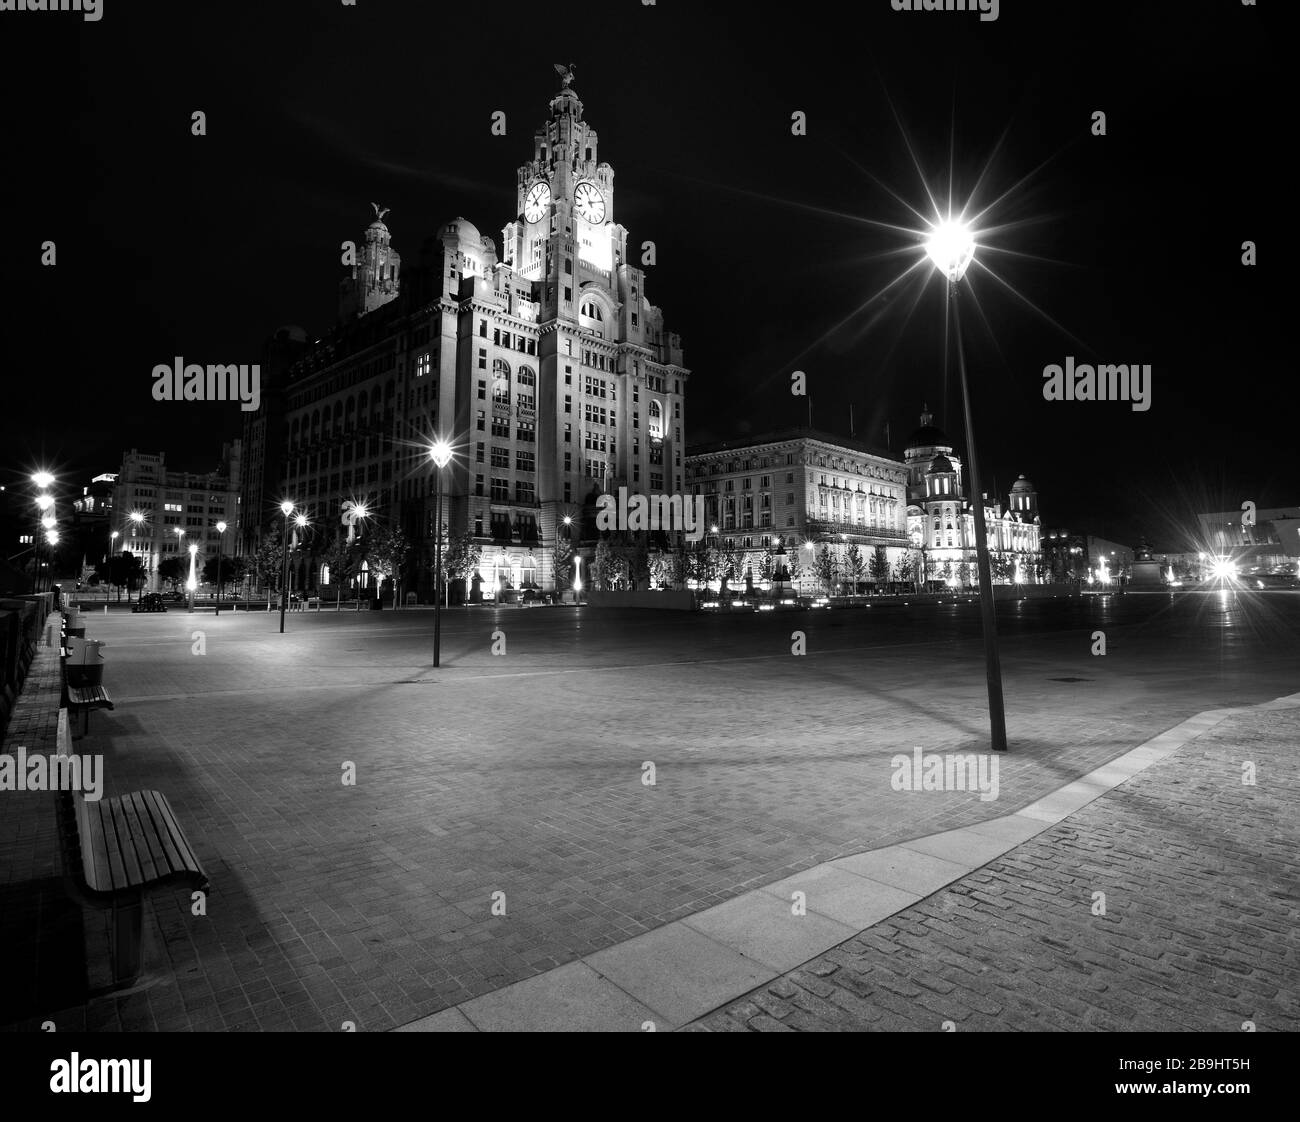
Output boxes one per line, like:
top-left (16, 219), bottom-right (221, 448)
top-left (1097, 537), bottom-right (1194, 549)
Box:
top-left (0, 598), bottom-right (1300, 1030)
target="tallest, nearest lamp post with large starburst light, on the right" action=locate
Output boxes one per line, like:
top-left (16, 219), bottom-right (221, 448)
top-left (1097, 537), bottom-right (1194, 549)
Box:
top-left (926, 220), bottom-right (1006, 751)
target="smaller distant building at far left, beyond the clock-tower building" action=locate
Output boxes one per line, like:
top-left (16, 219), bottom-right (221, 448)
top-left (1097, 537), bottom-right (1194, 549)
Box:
top-left (111, 441), bottom-right (242, 592)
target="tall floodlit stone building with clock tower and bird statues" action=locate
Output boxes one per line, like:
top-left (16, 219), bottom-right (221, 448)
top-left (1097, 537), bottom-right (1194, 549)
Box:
top-left (244, 73), bottom-right (690, 601)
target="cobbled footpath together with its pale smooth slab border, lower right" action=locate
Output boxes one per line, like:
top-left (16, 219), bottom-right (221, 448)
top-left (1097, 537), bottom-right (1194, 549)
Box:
top-left (397, 694), bottom-right (1300, 1032)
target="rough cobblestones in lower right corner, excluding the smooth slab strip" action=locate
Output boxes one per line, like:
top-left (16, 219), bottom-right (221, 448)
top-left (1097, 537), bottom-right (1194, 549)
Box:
top-left (684, 709), bottom-right (1300, 1032)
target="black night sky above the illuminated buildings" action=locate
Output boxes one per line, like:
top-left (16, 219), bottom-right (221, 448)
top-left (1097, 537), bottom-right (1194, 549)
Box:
top-left (0, 0), bottom-right (1279, 540)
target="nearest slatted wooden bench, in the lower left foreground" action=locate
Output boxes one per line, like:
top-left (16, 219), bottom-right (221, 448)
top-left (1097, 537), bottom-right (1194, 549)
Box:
top-left (57, 710), bottom-right (208, 989)
